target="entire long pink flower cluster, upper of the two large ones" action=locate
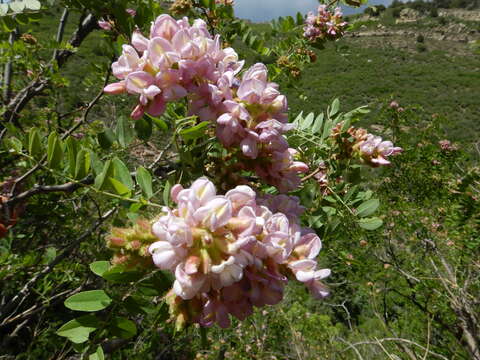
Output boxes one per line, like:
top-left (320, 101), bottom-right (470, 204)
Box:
top-left (105, 15), bottom-right (308, 191)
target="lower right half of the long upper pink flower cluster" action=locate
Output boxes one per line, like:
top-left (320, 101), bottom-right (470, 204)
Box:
top-left (217, 63), bottom-right (308, 192)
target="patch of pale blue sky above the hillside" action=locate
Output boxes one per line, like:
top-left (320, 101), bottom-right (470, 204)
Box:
top-left (234, 0), bottom-right (391, 22)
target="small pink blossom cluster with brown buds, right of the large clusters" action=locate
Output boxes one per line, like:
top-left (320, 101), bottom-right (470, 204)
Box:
top-left (332, 123), bottom-right (403, 167)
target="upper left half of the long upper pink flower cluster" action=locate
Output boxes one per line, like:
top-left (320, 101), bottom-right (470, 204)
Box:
top-left (105, 14), bottom-right (243, 119)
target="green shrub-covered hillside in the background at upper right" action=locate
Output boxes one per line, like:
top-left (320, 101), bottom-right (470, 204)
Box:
top-left (278, 15), bottom-right (480, 142)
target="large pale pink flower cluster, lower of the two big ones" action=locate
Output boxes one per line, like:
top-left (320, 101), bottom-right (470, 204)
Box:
top-left (149, 178), bottom-right (330, 328)
